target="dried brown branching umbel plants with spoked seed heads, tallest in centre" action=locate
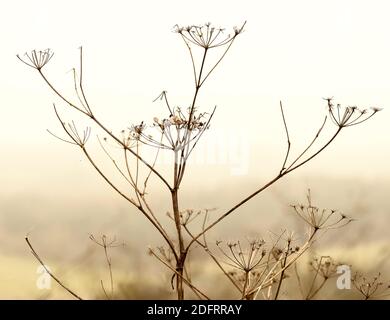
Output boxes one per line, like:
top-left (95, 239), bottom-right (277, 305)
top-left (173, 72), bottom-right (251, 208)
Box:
top-left (18, 23), bottom-right (380, 299)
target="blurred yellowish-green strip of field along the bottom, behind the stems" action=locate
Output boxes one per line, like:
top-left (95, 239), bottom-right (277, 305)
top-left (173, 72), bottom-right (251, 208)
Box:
top-left (0, 242), bottom-right (390, 299)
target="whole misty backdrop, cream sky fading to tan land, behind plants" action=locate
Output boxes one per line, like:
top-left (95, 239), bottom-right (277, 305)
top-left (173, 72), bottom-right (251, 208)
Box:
top-left (0, 0), bottom-right (390, 298)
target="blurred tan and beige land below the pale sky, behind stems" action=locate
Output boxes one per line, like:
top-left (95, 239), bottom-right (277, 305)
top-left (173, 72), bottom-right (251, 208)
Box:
top-left (0, 178), bottom-right (390, 299)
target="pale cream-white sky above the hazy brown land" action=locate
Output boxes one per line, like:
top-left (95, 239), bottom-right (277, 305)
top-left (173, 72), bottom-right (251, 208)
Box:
top-left (0, 0), bottom-right (390, 198)
